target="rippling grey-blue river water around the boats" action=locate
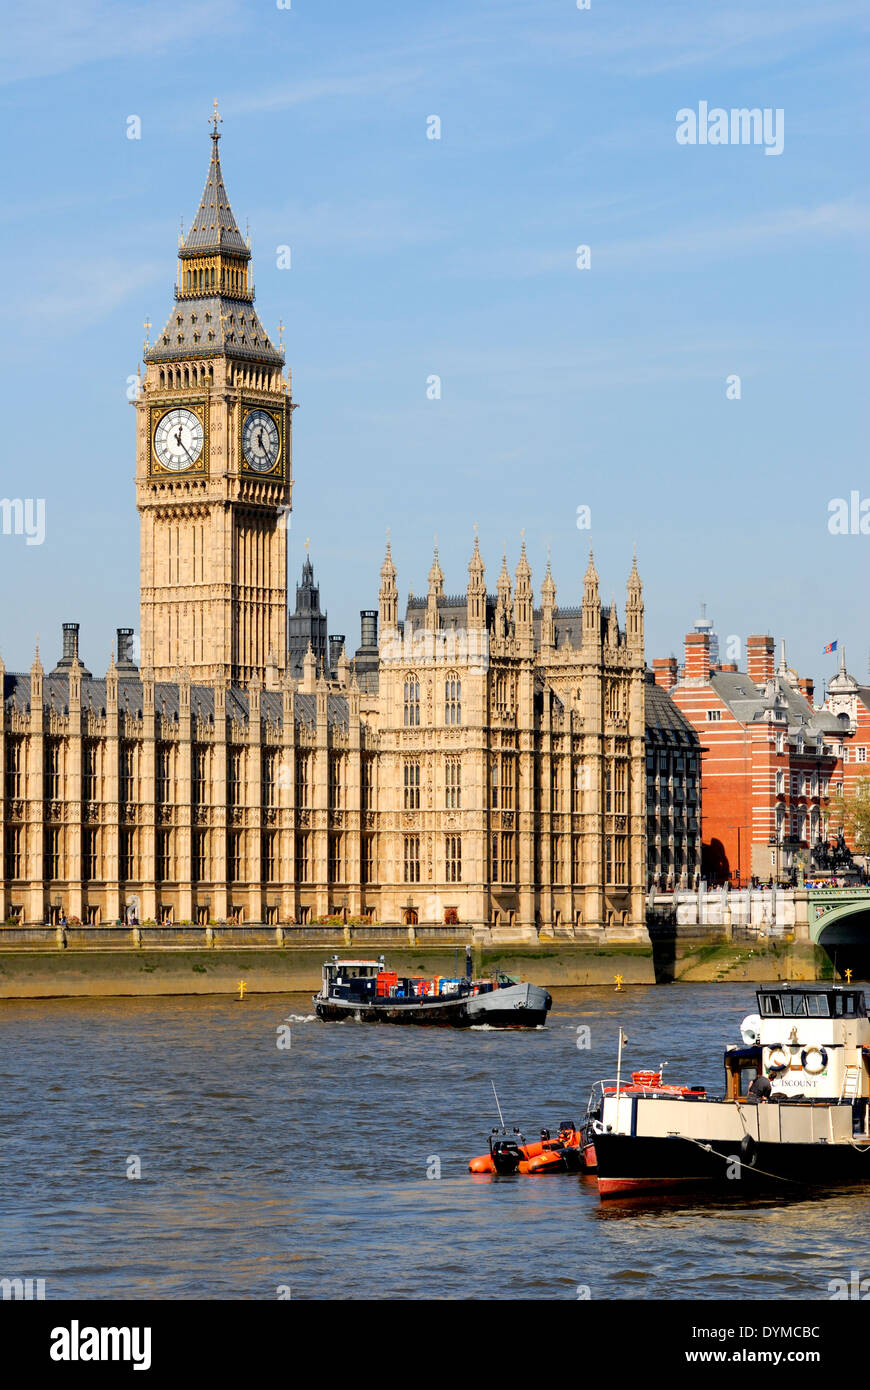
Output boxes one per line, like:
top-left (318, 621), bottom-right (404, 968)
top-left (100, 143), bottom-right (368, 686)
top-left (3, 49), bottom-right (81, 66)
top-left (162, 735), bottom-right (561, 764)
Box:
top-left (0, 986), bottom-right (870, 1300)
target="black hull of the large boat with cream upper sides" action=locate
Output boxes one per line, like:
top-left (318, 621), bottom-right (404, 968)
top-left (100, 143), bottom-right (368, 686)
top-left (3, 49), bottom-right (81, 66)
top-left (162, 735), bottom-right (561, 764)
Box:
top-left (595, 1134), bottom-right (870, 1200)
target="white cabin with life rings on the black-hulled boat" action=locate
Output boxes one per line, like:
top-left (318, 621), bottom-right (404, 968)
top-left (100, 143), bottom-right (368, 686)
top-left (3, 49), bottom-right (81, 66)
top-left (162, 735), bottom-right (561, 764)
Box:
top-left (725, 984), bottom-right (870, 1101)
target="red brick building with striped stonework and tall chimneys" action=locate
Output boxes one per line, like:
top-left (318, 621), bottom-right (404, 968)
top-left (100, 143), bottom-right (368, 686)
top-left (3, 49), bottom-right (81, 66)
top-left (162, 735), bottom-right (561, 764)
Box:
top-left (653, 630), bottom-right (844, 884)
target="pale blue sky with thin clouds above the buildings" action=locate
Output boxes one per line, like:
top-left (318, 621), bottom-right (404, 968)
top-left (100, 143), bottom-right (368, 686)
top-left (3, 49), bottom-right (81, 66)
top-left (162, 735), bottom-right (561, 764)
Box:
top-left (0, 0), bottom-right (870, 682)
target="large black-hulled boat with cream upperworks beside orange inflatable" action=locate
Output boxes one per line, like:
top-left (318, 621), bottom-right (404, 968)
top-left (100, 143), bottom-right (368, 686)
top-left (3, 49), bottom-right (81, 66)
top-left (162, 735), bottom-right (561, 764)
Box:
top-left (586, 986), bottom-right (870, 1198)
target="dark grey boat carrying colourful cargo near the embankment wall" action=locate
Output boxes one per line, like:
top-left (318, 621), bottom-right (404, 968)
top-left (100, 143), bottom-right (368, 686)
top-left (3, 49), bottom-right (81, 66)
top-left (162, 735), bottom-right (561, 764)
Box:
top-left (314, 952), bottom-right (553, 1029)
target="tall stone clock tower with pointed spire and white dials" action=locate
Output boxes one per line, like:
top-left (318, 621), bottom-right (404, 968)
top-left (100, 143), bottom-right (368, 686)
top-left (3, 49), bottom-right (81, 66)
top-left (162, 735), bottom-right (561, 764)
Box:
top-left (136, 103), bottom-right (293, 684)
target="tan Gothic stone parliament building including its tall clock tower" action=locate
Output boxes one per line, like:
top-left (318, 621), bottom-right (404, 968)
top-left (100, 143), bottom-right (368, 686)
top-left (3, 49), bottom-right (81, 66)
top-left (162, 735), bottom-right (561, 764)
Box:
top-left (0, 115), bottom-right (691, 941)
